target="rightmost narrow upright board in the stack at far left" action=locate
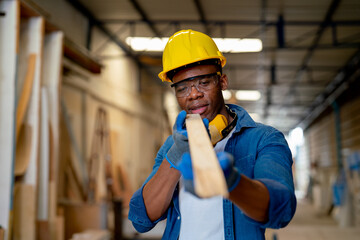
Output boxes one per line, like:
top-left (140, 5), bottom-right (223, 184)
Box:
top-left (41, 31), bottom-right (64, 239)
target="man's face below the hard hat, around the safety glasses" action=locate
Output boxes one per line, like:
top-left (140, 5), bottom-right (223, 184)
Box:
top-left (173, 65), bottom-right (227, 121)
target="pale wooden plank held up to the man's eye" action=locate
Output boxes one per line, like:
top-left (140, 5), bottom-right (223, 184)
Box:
top-left (186, 114), bottom-right (228, 198)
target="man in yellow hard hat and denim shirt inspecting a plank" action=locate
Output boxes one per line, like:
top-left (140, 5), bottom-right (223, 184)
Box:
top-left (129, 30), bottom-right (296, 240)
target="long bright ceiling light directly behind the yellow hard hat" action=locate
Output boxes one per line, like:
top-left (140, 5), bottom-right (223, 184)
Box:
top-left (126, 37), bottom-right (262, 53)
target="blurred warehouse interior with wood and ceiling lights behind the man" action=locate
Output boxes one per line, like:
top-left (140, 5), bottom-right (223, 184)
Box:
top-left (0, 0), bottom-right (360, 240)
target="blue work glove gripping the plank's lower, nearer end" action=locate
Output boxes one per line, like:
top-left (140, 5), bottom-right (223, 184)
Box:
top-left (178, 152), bottom-right (241, 196)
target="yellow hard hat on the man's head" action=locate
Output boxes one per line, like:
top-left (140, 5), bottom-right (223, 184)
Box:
top-left (159, 29), bottom-right (226, 82)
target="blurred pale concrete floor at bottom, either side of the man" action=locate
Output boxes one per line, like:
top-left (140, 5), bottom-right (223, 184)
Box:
top-left (124, 200), bottom-right (360, 240)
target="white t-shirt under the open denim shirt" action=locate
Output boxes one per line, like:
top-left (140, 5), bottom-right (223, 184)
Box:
top-left (179, 129), bottom-right (234, 240)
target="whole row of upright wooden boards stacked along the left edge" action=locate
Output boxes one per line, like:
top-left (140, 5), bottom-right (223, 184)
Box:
top-left (0, 0), bottom-right (63, 240)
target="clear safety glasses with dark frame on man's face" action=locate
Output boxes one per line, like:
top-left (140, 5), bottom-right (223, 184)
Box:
top-left (171, 72), bottom-right (221, 98)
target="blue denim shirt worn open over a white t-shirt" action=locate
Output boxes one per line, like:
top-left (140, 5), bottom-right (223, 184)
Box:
top-left (128, 105), bottom-right (296, 240)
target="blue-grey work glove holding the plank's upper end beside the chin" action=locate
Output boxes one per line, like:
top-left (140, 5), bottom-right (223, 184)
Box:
top-left (165, 110), bottom-right (209, 170)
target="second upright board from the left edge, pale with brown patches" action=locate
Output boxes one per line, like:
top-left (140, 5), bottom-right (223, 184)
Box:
top-left (14, 14), bottom-right (44, 239)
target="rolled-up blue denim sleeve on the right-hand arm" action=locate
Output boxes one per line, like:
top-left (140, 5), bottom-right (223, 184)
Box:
top-left (249, 128), bottom-right (296, 228)
